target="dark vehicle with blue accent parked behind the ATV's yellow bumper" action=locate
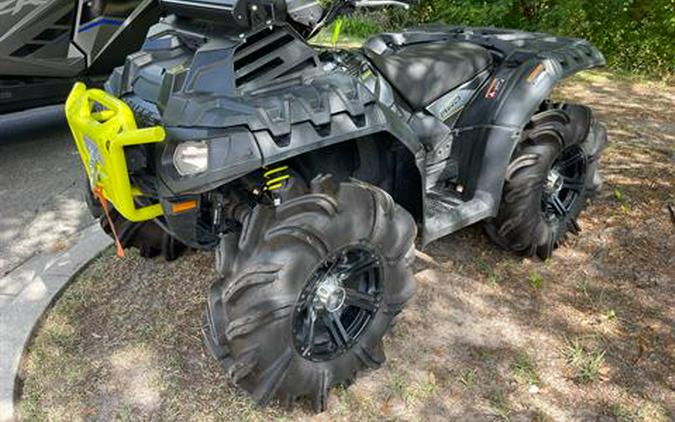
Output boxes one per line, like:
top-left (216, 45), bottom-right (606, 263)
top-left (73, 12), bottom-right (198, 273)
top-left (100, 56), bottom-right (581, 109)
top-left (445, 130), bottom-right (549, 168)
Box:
top-left (0, 0), bottom-right (160, 113)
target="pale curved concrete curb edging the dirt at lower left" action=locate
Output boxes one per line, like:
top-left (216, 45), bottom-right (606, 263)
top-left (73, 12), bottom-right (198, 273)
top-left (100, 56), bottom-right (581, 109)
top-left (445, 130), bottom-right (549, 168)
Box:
top-left (0, 224), bottom-right (112, 422)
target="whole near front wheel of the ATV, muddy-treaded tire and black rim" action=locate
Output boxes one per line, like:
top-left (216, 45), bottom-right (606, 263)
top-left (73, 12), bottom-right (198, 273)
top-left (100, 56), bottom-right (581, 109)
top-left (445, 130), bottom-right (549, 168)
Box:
top-left (204, 181), bottom-right (416, 411)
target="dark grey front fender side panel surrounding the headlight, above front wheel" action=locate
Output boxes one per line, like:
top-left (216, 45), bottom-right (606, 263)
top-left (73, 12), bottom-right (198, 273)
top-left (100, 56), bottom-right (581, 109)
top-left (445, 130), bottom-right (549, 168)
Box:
top-left (159, 93), bottom-right (423, 195)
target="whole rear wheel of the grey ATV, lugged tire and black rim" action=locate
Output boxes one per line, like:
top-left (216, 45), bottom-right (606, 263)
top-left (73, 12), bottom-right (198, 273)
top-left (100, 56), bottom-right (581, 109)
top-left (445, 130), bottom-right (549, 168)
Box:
top-left (486, 103), bottom-right (607, 260)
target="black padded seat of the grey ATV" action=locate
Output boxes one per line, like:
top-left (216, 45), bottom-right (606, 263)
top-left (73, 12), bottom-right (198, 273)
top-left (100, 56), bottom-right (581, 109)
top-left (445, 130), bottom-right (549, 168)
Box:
top-left (365, 41), bottom-right (492, 110)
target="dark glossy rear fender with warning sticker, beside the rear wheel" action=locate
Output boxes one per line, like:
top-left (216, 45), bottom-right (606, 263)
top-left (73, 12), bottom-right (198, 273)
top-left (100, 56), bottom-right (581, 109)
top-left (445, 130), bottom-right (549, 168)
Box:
top-left (453, 51), bottom-right (604, 216)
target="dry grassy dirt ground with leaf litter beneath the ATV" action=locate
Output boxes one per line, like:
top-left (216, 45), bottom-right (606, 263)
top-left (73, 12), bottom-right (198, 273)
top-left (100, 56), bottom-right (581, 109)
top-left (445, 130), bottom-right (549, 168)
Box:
top-left (19, 73), bottom-right (675, 422)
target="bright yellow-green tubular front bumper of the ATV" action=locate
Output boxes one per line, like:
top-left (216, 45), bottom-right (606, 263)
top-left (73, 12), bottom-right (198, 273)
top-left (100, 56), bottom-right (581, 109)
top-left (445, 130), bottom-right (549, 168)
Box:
top-left (66, 82), bottom-right (165, 221)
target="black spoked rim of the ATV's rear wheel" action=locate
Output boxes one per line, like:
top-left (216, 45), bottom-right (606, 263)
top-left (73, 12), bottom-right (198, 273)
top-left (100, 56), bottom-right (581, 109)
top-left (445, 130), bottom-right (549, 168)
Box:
top-left (541, 145), bottom-right (586, 220)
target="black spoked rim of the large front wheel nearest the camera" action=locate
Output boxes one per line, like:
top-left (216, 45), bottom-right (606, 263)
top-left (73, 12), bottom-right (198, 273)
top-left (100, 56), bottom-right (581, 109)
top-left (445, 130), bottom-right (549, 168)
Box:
top-left (293, 245), bottom-right (382, 361)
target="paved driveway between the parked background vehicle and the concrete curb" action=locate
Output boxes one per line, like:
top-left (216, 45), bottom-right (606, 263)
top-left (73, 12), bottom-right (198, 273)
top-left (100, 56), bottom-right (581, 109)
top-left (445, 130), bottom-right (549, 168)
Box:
top-left (0, 106), bottom-right (93, 276)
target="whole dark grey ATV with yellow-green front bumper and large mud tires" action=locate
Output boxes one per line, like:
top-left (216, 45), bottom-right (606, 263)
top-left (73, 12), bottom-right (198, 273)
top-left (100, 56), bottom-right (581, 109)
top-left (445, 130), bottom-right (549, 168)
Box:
top-left (66, 0), bottom-right (607, 411)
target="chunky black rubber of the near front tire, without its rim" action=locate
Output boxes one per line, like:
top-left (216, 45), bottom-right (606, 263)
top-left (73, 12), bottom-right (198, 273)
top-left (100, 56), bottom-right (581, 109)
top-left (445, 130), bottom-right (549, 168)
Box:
top-left (203, 178), bottom-right (417, 412)
